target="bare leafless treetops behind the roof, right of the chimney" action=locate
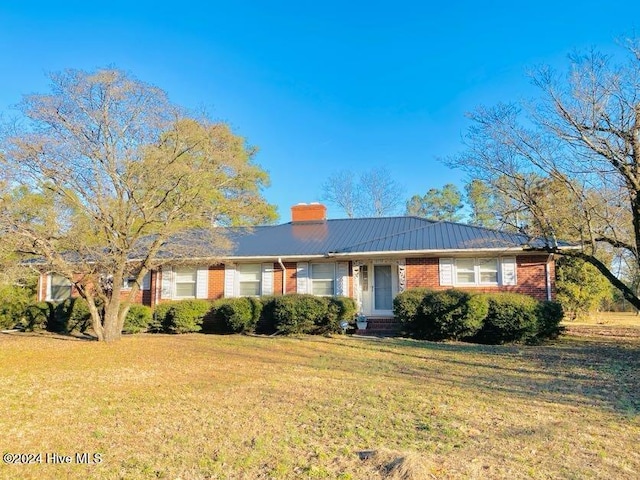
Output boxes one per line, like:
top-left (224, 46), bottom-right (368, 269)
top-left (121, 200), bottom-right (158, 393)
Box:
top-left (322, 167), bottom-right (403, 218)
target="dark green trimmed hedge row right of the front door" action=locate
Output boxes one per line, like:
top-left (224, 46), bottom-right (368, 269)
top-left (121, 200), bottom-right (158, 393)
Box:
top-left (393, 289), bottom-right (563, 344)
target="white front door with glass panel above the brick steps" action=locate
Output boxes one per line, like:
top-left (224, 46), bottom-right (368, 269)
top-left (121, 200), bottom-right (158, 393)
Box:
top-left (360, 263), bottom-right (398, 316)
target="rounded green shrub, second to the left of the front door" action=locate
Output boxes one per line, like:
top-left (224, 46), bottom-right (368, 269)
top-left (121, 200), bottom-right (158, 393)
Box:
top-left (273, 293), bottom-right (328, 335)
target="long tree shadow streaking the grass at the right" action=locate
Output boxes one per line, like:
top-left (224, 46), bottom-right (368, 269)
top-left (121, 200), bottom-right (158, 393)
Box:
top-left (312, 338), bottom-right (640, 415)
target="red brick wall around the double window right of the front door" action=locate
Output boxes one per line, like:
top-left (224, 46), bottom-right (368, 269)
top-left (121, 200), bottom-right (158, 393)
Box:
top-left (406, 255), bottom-right (555, 300)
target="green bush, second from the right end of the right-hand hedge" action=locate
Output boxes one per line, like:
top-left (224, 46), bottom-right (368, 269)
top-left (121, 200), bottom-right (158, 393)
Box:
top-left (475, 293), bottom-right (539, 345)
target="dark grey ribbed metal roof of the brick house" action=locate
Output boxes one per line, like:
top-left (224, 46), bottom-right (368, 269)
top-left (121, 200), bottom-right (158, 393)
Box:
top-left (221, 216), bottom-right (568, 257)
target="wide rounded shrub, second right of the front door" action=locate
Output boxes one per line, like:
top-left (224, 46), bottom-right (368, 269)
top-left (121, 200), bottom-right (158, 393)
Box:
top-left (413, 289), bottom-right (489, 340)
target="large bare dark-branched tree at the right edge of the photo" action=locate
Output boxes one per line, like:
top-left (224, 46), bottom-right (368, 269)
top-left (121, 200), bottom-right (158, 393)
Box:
top-left (449, 40), bottom-right (640, 308)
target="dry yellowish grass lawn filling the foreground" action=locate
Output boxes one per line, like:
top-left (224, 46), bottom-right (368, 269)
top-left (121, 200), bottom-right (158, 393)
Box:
top-left (0, 326), bottom-right (640, 480)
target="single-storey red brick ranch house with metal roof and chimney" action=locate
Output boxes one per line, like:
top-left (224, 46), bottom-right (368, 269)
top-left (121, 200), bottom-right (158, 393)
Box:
top-left (38, 203), bottom-right (568, 334)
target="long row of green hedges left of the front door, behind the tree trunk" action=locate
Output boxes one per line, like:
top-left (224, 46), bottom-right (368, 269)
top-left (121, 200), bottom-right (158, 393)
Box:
top-left (5, 294), bottom-right (356, 335)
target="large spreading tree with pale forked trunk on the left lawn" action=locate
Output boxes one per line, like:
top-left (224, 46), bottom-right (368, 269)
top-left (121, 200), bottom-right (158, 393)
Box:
top-left (0, 70), bottom-right (275, 341)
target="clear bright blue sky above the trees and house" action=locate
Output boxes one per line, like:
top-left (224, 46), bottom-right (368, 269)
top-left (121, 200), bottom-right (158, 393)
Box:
top-left (0, 0), bottom-right (640, 221)
